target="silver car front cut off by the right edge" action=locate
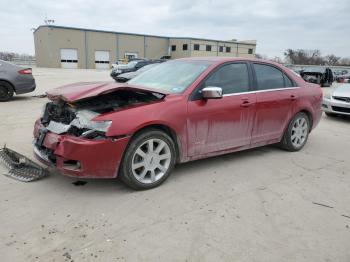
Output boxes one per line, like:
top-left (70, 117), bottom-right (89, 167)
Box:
top-left (322, 84), bottom-right (350, 116)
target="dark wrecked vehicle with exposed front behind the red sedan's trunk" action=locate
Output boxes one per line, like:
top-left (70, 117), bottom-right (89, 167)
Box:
top-left (300, 67), bottom-right (334, 87)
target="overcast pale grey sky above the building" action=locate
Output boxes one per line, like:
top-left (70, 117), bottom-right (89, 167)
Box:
top-left (0, 0), bottom-right (350, 57)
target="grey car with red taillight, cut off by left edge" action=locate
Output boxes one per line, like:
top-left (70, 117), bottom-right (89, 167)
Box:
top-left (0, 60), bottom-right (36, 102)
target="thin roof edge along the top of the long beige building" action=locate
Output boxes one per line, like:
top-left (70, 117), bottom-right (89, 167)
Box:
top-left (34, 25), bottom-right (256, 46)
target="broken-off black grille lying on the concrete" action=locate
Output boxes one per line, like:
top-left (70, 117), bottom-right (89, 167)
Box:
top-left (0, 146), bottom-right (49, 182)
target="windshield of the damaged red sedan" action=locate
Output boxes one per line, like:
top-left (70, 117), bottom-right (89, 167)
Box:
top-left (128, 61), bottom-right (212, 93)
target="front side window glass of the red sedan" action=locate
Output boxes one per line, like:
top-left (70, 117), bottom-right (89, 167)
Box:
top-left (204, 63), bottom-right (249, 95)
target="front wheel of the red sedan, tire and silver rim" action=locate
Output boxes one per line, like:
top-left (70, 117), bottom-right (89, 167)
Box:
top-left (119, 128), bottom-right (176, 190)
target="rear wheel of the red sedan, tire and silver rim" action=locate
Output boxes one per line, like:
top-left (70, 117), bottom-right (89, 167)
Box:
top-left (280, 112), bottom-right (310, 152)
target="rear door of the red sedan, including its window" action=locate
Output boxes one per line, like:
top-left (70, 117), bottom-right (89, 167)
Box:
top-left (252, 63), bottom-right (298, 145)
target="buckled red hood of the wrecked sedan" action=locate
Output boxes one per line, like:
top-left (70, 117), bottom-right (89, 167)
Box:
top-left (46, 82), bottom-right (169, 102)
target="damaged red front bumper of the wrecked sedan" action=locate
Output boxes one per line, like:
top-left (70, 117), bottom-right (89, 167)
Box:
top-left (34, 121), bottom-right (129, 178)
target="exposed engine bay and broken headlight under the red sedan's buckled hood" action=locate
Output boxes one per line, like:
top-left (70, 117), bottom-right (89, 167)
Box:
top-left (41, 90), bottom-right (164, 139)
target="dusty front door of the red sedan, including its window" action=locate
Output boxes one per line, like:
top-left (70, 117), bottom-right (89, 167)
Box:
top-left (187, 62), bottom-right (256, 156)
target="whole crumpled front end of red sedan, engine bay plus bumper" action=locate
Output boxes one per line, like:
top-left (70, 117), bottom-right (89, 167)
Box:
top-left (34, 90), bottom-right (164, 178)
